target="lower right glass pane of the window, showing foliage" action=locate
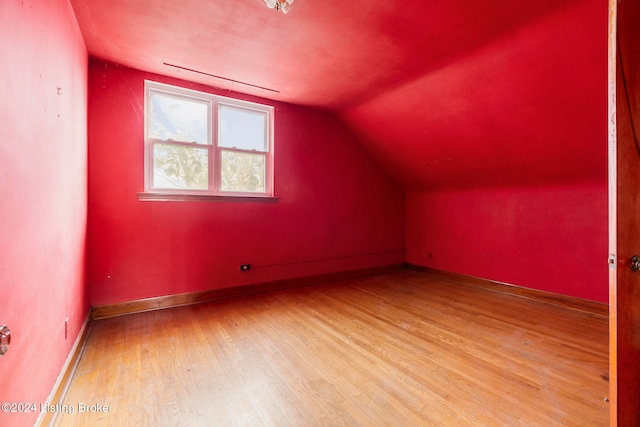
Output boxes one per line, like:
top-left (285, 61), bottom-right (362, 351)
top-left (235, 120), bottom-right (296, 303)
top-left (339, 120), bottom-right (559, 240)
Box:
top-left (220, 150), bottom-right (266, 193)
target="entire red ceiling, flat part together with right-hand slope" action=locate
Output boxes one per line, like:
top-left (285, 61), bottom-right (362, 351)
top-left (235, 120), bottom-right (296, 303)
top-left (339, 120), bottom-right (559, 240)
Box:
top-left (71, 0), bottom-right (607, 189)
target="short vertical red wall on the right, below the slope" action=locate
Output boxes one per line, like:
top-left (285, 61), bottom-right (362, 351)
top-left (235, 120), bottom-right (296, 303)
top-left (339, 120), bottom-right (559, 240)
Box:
top-left (407, 183), bottom-right (608, 302)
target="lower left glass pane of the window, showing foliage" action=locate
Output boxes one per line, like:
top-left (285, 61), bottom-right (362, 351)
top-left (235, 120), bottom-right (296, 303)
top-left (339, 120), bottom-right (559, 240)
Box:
top-left (153, 143), bottom-right (209, 190)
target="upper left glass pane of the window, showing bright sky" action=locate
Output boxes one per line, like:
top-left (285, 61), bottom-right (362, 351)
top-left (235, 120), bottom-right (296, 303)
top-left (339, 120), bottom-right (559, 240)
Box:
top-left (149, 92), bottom-right (209, 144)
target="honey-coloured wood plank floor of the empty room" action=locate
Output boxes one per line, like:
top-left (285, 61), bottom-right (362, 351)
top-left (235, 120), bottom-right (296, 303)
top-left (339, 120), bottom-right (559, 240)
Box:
top-left (54, 270), bottom-right (609, 427)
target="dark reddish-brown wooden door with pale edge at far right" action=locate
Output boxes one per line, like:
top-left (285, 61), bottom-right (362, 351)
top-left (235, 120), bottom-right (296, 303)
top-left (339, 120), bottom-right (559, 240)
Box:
top-left (608, 0), bottom-right (640, 427)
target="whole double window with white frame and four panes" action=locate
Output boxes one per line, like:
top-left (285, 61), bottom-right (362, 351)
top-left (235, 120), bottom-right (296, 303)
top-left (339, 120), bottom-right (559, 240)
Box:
top-left (145, 81), bottom-right (273, 198)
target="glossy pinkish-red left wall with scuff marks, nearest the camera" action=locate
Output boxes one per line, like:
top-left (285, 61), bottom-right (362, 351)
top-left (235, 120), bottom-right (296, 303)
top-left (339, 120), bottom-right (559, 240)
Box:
top-left (0, 0), bottom-right (89, 426)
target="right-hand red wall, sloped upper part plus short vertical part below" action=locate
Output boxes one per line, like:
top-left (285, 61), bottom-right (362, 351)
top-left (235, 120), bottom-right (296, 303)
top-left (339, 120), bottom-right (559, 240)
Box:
top-left (341, 0), bottom-right (608, 302)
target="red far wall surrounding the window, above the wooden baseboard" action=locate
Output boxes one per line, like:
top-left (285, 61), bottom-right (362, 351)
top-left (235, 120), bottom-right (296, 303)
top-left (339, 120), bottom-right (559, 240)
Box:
top-left (88, 61), bottom-right (404, 305)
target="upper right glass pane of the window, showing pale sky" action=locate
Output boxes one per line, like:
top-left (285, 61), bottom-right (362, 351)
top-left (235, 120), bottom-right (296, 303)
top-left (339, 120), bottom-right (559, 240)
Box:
top-left (218, 105), bottom-right (268, 151)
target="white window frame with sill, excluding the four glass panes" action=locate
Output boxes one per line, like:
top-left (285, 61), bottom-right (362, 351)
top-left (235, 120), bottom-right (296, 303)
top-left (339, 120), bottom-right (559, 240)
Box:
top-left (138, 80), bottom-right (274, 200)
